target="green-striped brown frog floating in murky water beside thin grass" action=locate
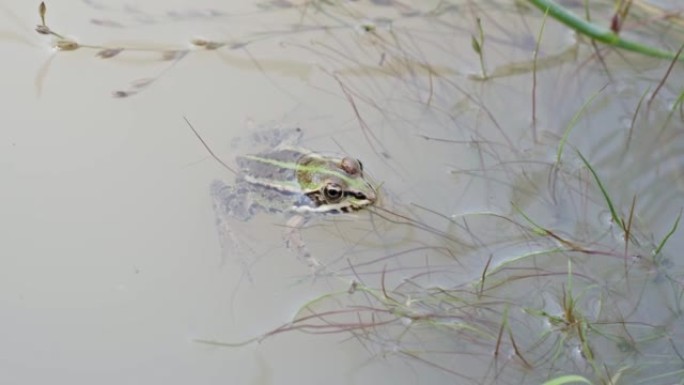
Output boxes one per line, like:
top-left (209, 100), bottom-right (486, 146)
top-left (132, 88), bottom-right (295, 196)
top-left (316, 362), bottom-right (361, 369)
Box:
top-left (211, 129), bottom-right (377, 264)
